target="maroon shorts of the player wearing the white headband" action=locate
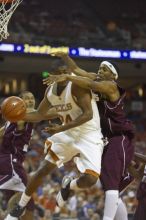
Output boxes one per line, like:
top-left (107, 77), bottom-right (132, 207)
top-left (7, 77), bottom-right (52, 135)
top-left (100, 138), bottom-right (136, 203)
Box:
top-left (100, 135), bottom-right (134, 191)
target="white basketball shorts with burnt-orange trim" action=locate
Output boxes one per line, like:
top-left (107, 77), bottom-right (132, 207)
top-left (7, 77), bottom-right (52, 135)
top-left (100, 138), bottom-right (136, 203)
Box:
top-left (45, 129), bottom-right (104, 176)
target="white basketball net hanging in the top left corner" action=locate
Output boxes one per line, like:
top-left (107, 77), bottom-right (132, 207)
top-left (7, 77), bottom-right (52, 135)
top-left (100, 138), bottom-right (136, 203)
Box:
top-left (0, 0), bottom-right (23, 41)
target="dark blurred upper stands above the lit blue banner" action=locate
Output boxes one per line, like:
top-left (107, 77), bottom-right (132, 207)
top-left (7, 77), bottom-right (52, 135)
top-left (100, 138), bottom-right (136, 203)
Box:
top-left (4, 0), bottom-right (146, 49)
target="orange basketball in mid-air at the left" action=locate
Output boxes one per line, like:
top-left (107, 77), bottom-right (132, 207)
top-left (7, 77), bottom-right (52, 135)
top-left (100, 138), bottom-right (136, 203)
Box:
top-left (1, 96), bottom-right (26, 122)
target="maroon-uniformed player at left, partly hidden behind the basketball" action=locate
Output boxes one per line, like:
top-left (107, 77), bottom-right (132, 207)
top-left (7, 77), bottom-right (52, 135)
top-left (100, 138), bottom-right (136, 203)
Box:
top-left (0, 91), bottom-right (47, 220)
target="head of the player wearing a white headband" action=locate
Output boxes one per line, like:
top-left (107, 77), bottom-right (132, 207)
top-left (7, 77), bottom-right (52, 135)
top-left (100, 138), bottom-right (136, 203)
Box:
top-left (98, 61), bottom-right (119, 80)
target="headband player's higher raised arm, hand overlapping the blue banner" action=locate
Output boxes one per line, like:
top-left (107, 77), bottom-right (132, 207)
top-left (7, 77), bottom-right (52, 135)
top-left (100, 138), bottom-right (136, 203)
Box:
top-left (50, 52), bottom-right (97, 80)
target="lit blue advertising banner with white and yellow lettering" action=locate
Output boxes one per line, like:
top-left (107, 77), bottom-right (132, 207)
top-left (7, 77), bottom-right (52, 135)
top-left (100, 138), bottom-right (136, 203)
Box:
top-left (0, 43), bottom-right (146, 60)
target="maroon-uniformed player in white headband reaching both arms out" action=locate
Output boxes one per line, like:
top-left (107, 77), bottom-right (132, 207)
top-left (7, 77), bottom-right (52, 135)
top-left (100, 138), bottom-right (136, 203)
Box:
top-left (44, 52), bottom-right (134, 220)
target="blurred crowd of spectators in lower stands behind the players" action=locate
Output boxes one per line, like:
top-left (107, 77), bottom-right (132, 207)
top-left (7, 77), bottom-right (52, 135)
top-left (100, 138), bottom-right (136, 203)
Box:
top-left (0, 85), bottom-right (146, 220)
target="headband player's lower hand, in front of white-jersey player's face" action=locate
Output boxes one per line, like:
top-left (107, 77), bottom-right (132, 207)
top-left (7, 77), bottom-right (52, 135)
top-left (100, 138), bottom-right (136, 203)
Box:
top-left (43, 74), bottom-right (68, 86)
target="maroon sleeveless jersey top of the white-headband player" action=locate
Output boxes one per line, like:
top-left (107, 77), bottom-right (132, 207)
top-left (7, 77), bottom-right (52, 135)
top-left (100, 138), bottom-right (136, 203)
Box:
top-left (97, 87), bottom-right (134, 138)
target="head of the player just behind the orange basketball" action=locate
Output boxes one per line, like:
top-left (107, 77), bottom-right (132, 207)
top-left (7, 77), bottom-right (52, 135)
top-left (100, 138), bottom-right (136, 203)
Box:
top-left (19, 91), bottom-right (35, 111)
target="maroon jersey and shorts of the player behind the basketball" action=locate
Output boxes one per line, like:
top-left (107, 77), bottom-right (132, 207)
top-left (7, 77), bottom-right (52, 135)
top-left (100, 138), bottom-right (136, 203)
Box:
top-left (0, 123), bottom-right (34, 211)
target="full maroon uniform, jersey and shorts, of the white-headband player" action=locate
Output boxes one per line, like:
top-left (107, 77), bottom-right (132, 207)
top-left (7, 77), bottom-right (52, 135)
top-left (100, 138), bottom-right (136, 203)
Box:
top-left (97, 84), bottom-right (134, 191)
